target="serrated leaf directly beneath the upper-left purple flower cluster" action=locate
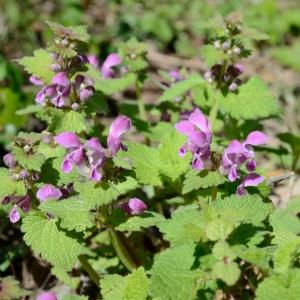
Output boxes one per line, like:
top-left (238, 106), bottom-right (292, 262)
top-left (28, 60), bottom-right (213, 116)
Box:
top-left (49, 109), bottom-right (86, 133)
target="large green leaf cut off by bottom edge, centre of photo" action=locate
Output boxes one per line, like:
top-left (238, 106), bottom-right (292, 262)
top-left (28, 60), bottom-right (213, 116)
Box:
top-left (150, 243), bottom-right (196, 300)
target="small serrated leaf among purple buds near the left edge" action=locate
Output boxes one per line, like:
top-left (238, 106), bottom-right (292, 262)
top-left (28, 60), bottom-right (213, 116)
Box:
top-left (12, 146), bottom-right (46, 171)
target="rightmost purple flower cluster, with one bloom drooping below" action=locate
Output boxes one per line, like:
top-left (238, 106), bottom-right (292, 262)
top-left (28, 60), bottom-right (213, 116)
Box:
top-left (220, 131), bottom-right (268, 196)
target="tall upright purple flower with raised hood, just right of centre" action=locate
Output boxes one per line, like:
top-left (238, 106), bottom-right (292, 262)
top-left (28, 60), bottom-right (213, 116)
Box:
top-left (175, 108), bottom-right (212, 170)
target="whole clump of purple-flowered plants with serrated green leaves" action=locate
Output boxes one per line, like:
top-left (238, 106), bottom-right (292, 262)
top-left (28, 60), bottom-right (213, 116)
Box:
top-left (0, 15), bottom-right (300, 300)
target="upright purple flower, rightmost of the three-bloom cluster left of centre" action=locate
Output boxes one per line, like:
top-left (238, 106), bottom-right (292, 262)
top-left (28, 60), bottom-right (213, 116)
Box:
top-left (107, 116), bottom-right (131, 155)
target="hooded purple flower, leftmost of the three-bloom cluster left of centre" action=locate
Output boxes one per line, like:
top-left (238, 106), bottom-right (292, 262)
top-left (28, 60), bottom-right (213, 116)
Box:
top-left (54, 132), bottom-right (84, 173)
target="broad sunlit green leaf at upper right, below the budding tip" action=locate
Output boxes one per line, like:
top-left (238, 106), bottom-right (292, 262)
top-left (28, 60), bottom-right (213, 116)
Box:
top-left (220, 77), bottom-right (279, 120)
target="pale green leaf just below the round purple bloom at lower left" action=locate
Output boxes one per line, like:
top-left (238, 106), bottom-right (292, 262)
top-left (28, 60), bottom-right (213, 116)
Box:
top-left (39, 197), bottom-right (93, 231)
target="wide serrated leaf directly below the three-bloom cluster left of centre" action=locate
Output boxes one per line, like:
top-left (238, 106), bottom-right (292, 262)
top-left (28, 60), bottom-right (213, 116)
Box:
top-left (74, 177), bottom-right (138, 209)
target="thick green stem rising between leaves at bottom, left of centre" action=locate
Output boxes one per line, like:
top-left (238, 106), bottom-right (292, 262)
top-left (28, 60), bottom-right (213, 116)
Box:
top-left (107, 226), bottom-right (140, 271)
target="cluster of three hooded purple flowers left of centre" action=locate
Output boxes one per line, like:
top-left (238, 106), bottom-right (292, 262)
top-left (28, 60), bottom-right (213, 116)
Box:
top-left (55, 116), bottom-right (131, 181)
